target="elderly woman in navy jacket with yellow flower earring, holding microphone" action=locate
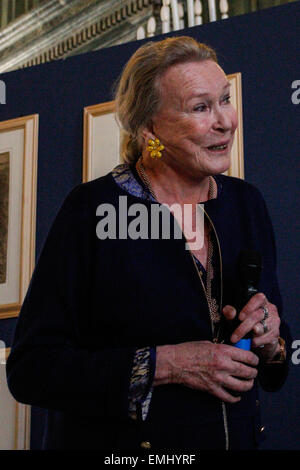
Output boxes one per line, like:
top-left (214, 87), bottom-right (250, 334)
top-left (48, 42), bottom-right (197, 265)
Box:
top-left (7, 37), bottom-right (286, 452)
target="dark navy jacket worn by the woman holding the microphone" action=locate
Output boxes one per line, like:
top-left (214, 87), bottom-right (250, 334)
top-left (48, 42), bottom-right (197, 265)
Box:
top-left (7, 174), bottom-right (283, 450)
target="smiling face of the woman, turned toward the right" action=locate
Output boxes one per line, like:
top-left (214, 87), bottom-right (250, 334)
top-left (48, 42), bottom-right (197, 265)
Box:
top-left (152, 60), bottom-right (237, 177)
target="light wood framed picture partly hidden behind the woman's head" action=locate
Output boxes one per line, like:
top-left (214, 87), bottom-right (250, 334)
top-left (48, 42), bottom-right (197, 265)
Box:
top-left (83, 73), bottom-right (244, 182)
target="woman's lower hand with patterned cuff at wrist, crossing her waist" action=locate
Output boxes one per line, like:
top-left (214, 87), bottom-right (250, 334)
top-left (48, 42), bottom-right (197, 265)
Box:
top-left (154, 341), bottom-right (259, 403)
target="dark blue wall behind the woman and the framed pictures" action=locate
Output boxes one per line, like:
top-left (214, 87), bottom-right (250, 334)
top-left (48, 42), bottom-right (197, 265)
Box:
top-left (0, 2), bottom-right (300, 449)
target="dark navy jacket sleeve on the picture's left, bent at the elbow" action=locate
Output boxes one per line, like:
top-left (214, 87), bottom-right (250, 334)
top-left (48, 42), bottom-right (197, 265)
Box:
top-left (7, 185), bottom-right (135, 419)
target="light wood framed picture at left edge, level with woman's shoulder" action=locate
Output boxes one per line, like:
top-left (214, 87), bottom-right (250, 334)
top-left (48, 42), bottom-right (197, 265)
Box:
top-left (0, 114), bottom-right (38, 318)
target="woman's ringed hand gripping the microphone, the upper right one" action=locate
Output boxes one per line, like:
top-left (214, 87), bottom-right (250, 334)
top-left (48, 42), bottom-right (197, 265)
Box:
top-left (223, 293), bottom-right (280, 361)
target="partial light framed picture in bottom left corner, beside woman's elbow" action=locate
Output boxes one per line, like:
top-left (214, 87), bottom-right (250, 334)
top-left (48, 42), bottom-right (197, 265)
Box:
top-left (0, 344), bottom-right (30, 450)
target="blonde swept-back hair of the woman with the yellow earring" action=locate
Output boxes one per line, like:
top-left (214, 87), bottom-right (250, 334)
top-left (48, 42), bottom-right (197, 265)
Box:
top-left (115, 36), bottom-right (217, 164)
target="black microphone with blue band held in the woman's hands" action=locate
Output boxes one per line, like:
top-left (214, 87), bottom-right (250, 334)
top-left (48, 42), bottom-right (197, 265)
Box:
top-left (232, 250), bottom-right (262, 351)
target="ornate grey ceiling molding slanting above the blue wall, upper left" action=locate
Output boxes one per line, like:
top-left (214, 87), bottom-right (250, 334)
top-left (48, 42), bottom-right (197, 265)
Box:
top-left (0, 0), bottom-right (154, 73)
